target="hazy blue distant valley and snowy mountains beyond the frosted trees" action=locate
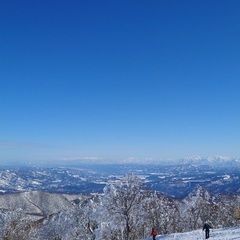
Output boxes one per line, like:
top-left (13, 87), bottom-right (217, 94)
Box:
top-left (0, 157), bottom-right (240, 198)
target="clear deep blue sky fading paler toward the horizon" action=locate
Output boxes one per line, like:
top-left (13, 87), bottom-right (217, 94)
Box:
top-left (0, 0), bottom-right (240, 162)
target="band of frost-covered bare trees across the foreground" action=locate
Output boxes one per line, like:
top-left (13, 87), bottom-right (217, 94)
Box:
top-left (0, 175), bottom-right (240, 240)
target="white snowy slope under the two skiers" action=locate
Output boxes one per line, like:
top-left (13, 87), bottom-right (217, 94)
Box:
top-left (146, 227), bottom-right (240, 240)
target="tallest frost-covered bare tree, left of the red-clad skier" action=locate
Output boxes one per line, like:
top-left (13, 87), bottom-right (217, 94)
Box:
top-left (100, 175), bottom-right (144, 240)
